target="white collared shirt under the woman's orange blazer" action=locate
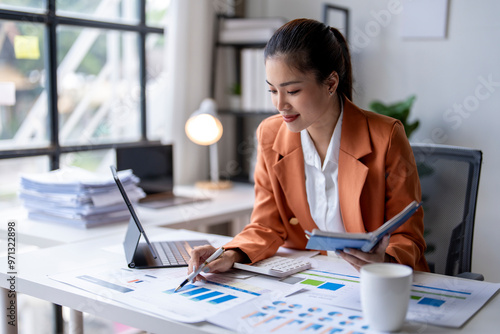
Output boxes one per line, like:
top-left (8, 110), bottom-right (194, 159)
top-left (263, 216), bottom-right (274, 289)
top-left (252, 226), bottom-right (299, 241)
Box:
top-left (300, 109), bottom-right (345, 232)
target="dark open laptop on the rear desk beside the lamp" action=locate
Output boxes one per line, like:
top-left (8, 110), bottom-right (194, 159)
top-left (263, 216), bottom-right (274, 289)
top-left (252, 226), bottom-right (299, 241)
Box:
top-left (116, 143), bottom-right (206, 209)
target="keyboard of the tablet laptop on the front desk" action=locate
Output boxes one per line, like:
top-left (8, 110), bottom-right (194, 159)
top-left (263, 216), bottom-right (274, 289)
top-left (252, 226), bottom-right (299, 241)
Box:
top-left (151, 240), bottom-right (206, 266)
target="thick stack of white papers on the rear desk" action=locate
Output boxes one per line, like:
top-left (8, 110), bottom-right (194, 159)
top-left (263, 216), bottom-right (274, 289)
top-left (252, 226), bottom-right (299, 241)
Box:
top-left (19, 167), bottom-right (145, 228)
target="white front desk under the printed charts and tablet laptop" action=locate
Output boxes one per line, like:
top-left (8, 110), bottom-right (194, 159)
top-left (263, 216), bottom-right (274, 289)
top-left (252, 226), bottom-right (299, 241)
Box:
top-left (0, 228), bottom-right (500, 333)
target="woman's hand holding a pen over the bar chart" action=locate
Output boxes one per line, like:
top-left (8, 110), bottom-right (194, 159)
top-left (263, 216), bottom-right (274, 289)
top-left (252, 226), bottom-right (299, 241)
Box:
top-left (188, 245), bottom-right (244, 282)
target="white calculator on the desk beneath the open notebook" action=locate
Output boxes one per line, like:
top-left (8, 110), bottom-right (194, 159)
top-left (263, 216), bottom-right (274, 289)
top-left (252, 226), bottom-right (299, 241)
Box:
top-left (233, 255), bottom-right (311, 277)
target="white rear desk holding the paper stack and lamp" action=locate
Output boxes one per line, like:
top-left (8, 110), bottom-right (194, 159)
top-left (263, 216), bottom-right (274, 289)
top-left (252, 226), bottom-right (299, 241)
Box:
top-left (0, 183), bottom-right (254, 248)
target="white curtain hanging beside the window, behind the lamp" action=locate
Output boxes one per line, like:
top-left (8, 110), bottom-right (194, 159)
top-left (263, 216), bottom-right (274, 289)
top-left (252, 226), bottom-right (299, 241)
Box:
top-left (162, 0), bottom-right (215, 184)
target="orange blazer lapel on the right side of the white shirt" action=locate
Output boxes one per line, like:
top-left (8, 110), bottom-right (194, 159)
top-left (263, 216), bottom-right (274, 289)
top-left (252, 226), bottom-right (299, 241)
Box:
top-left (338, 99), bottom-right (372, 233)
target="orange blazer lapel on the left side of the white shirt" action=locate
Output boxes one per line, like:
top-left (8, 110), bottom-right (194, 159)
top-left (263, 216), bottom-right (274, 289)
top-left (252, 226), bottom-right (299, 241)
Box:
top-left (273, 123), bottom-right (318, 231)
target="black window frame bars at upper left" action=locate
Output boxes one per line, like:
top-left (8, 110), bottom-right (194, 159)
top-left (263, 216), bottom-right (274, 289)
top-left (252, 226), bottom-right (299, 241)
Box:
top-left (0, 0), bottom-right (166, 170)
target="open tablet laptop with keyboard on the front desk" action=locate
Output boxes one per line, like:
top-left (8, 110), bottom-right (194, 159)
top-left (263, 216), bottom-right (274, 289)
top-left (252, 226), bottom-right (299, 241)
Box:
top-left (110, 166), bottom-right (210, 269)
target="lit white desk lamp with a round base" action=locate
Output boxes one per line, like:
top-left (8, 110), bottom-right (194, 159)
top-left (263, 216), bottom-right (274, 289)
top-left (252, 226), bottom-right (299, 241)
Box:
top-left (185, 98), bottom-right (232, 189)
